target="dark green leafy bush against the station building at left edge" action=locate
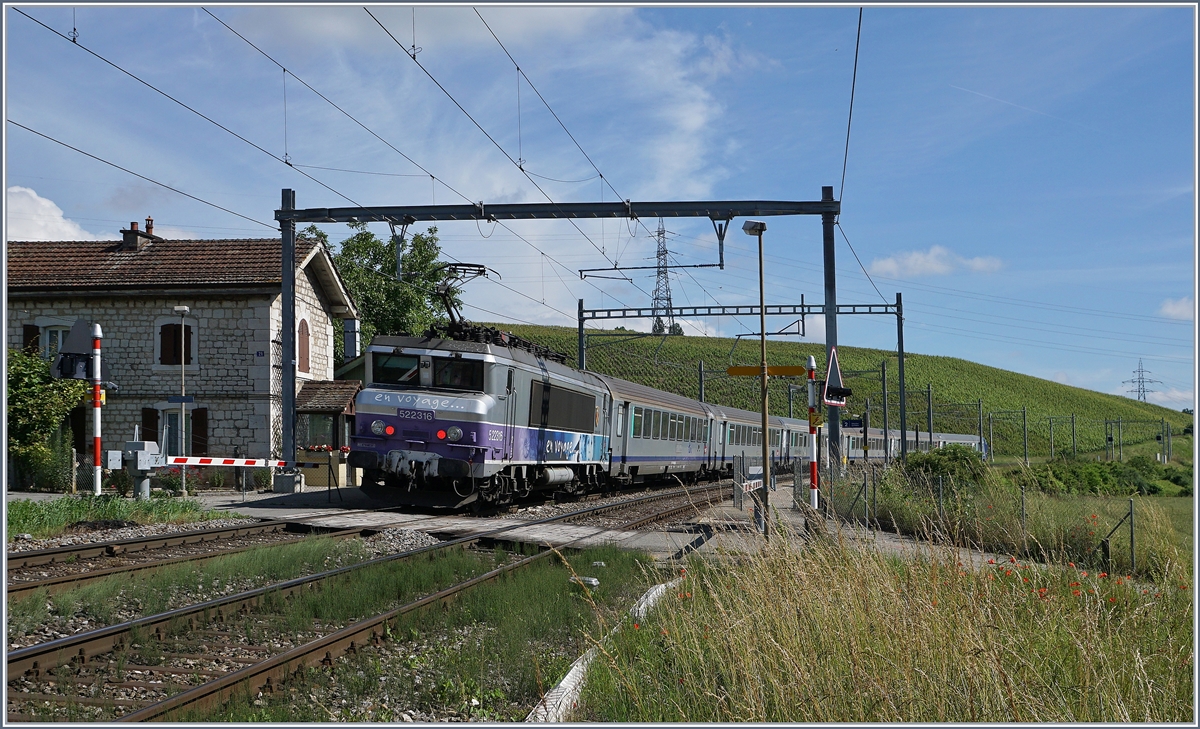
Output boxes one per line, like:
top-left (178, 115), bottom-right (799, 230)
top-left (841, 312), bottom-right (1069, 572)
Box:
top-left (7, 349), bottom-right (88, 486)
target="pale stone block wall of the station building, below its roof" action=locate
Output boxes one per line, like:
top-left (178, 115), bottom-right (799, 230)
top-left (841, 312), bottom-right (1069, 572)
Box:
top-left (8, 273), bottom-right (334, 458)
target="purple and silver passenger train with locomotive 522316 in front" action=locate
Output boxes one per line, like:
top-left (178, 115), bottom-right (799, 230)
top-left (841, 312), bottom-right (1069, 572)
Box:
top-left (348, 323), bottom-right (986, 510)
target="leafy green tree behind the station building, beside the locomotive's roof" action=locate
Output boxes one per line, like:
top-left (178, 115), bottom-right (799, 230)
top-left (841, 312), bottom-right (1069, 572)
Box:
top-left (312, 223), bottom-right (458, 362)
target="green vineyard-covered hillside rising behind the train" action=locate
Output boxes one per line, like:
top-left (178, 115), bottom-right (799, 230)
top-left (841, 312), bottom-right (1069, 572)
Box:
top-left (480, 324), bottom-right (1192, 457)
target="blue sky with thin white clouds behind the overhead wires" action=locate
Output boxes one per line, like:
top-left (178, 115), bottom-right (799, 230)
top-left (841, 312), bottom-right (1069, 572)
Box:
top-left (4, 4), bottom-right (1196, 409)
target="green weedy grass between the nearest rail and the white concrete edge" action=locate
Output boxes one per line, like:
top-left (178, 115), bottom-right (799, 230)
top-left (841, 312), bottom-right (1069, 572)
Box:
top-left (180, 548), bottom-right (649, 722)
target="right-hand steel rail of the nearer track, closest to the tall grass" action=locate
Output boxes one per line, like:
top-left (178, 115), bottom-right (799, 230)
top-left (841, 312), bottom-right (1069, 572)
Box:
top-left (116, 487), bottom-right (720, 722)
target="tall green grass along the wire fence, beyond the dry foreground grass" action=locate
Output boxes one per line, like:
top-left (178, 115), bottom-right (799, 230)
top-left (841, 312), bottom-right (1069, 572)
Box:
top-left (833, 468), bottom-right (1192, 578)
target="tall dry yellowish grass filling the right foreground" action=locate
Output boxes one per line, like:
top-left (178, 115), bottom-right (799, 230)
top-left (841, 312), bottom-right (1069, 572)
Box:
top-left (575, 538), bottom-right (1195, 723)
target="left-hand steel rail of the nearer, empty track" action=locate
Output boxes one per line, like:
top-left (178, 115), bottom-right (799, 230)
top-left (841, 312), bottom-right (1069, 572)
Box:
top-left (7, 486), bottom-right (726, 676)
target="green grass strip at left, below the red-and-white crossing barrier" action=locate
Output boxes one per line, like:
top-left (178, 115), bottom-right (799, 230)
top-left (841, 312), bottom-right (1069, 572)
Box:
top-left (7, 495), bottom-right (240, 541)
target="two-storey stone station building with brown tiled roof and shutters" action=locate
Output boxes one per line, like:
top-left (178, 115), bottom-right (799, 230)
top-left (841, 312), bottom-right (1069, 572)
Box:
top-left (7, 218), bottom-right (358, 472)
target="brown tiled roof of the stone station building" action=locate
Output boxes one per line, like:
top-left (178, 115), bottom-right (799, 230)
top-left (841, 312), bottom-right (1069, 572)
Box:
top-left (7, 237), bottom-right (317, 293)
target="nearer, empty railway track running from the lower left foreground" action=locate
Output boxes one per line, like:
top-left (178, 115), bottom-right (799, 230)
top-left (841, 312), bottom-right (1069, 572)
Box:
top-left (7, 484), bottom-right (730, 721)
